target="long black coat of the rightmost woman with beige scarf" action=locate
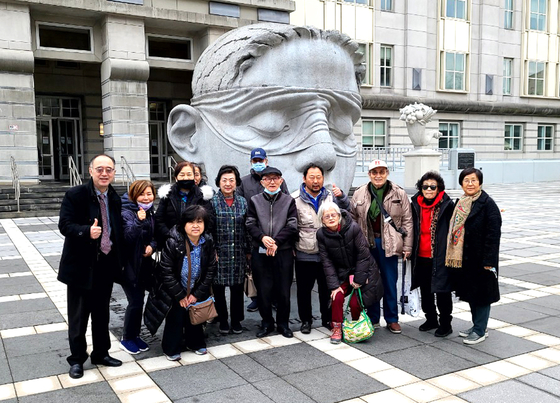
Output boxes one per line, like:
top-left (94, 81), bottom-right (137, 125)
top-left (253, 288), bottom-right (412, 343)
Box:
top-left (449, 190), bottom-right (502, 305)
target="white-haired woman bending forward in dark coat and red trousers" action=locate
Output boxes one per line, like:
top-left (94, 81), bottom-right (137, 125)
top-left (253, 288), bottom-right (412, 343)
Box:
top-left (317, 202), bottom-right (383, 344)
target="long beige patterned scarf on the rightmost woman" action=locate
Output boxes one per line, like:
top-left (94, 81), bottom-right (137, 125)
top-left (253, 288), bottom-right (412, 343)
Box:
top-left (445, 190), bottom-right (482, 268)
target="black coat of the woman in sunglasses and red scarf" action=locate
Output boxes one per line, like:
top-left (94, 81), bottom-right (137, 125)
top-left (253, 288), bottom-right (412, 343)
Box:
top-left (410, 192), bottom-right (453, 293)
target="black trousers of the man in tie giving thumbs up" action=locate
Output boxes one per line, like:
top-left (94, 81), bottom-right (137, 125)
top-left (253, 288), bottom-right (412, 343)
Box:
top-left (66, 252), bottom-right (118, 365)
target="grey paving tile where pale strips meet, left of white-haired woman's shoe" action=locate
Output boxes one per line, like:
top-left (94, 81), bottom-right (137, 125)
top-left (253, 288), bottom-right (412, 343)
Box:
top-left (249, 343), bottom-right (339, 376)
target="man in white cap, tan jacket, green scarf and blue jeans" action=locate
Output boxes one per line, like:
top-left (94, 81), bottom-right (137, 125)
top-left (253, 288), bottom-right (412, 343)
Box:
top-left (351, 160), bottom-right (414, 334)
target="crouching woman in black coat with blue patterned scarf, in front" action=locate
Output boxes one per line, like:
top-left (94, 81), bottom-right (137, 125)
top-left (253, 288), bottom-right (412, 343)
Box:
top-left (144, 206), bottom-right (216, 361)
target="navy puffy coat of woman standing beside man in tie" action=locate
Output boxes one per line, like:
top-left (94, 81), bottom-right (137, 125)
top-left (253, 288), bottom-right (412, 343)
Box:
top-left (121, 193), bottom-right (157, 286)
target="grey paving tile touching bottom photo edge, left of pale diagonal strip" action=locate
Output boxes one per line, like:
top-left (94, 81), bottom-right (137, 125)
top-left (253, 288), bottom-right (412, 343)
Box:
top-left (283, 363), bottom-right (387, 403)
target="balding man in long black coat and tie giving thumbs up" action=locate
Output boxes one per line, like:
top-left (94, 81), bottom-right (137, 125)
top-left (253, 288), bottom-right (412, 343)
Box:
top-left (58, 155), bottom-right (122, 378)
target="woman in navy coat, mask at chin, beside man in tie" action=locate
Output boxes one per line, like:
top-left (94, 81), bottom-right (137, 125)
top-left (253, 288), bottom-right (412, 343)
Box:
top-left (120, 180), bottom-right (156, 354)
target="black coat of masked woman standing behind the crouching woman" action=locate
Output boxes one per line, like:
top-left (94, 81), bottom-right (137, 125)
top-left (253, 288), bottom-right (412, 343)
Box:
top-left (156, 183), bottom-right (214, 247)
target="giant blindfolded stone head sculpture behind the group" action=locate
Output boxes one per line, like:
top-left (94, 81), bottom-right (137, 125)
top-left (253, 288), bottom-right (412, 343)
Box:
top-left (168, 24), bottom-right (365, 190)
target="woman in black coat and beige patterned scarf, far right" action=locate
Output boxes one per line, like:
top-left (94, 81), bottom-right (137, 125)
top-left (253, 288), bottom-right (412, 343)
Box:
top-left (445, 168), bottom-right (502, 345)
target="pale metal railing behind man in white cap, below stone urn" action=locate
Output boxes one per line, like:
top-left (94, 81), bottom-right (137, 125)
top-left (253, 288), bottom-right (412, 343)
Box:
top-left (356, 146), bottom-right (449, 172)
